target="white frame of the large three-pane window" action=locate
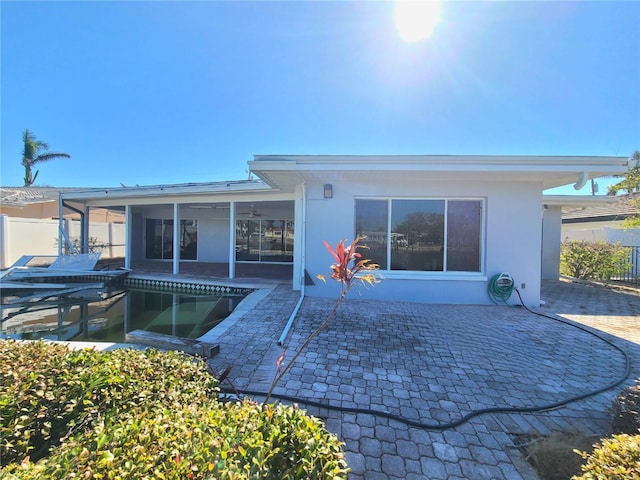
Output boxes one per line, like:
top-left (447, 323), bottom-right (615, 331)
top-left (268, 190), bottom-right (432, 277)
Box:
top-left (353, 196), bottom-right (488, 281)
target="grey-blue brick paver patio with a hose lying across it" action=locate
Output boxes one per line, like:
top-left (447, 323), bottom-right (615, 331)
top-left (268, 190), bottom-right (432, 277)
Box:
top-left (205, 282), bottom-right (640, 480)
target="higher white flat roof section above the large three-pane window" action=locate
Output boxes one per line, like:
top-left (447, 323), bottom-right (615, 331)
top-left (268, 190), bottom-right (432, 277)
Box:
top-left (249, 155), bottom-right (629, 191)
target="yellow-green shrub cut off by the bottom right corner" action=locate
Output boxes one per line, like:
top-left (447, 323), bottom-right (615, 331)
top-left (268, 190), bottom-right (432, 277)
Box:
top-left (573, 434), bottom-right (640, 480)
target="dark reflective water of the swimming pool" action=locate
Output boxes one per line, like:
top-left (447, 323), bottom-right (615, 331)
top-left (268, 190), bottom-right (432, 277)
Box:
top-left (0, 288), bottom-right (245, 343)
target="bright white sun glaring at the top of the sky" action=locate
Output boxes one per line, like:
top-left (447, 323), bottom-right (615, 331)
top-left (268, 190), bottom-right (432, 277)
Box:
top-left (395, 0), bottom-right (440, 42)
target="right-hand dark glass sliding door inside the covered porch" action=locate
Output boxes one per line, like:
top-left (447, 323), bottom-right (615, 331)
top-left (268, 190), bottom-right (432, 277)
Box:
top-left (236, 220), bottom-right (293, 263)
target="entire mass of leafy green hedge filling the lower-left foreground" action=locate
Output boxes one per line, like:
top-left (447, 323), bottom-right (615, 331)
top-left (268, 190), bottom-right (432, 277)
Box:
top-left (0, 341), bottom-right (348, 480)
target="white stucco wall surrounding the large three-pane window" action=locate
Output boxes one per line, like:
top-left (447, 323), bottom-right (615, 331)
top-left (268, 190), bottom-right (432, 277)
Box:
top-left (305, 177), bottom-right (542, 305)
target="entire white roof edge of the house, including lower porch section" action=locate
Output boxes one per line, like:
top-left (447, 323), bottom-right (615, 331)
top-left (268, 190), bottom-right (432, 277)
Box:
top-left (28, 155), bottom-right (628, 204)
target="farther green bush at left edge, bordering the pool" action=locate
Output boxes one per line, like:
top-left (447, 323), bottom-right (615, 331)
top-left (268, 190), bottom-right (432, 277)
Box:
top-left (0, 341), bottom-right (218, 464)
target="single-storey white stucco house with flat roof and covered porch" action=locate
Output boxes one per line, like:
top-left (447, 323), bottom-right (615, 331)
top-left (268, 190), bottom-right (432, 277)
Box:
top-left (60, 155), bottom-right (627, 305)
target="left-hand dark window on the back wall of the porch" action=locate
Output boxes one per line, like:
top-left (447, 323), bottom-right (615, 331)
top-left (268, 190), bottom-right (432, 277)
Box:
top-left (146, 218), bottom-right (198, 260)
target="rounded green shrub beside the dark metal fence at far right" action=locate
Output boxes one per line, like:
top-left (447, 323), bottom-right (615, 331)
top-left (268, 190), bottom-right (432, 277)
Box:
top-left (560, 240), bottom-right (631, 281)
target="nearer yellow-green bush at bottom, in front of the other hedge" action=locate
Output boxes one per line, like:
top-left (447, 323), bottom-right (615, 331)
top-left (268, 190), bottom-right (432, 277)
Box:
top-left (5, 401), bottom-right (347, 480)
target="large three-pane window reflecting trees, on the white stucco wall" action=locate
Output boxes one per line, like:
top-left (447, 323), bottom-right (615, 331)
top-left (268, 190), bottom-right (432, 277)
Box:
top-left (355, 199), bottom-right (483, 272)
